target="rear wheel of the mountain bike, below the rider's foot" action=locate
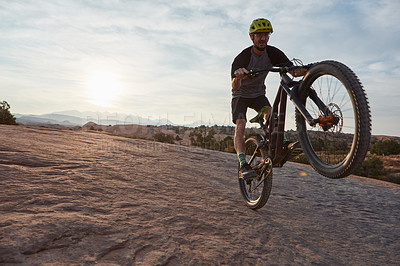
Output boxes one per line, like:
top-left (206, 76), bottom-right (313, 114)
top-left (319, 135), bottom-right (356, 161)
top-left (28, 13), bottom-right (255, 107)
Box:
top-left (239, 138), bottom-right (272, 210)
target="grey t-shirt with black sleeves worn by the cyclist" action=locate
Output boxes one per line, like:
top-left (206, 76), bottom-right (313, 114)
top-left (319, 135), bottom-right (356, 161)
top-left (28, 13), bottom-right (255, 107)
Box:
top-left (231, 45), bottom-right (293, 98)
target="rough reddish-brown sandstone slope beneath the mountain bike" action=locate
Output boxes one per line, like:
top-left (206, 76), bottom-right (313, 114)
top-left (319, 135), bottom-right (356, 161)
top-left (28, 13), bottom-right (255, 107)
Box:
top-left (0, 126), bottom-right (400, 265)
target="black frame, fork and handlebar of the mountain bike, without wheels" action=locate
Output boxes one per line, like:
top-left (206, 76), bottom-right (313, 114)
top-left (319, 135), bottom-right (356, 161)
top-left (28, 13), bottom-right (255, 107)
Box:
top-left (245, 65), bottom-right (333, 167)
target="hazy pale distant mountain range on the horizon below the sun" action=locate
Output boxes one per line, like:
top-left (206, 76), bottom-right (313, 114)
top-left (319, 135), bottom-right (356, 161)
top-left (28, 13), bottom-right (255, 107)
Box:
top-left (13, 110), bottom-right (173, 127)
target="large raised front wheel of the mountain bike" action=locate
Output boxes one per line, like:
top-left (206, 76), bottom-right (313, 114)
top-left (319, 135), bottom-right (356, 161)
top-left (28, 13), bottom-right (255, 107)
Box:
top-left (296, 61), bottom-right (371, 178)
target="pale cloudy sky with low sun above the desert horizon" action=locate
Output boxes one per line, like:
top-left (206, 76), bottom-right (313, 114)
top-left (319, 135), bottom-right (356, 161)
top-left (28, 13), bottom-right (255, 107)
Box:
top-left (0, 0), bottom-right (400, 136)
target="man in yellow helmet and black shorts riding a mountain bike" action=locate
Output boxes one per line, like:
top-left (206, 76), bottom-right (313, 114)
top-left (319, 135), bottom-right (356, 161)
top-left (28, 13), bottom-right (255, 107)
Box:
top-left (231, 18), bottom-right (305, 179)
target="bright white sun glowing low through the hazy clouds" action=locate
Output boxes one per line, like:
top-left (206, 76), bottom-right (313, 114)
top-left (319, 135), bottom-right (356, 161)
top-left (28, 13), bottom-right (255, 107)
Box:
top-left (87, 70), bottom-right (122, 107)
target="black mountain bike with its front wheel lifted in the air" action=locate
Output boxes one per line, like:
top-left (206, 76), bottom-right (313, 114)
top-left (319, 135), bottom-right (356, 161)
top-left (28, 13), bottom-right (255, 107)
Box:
top-left (239, 61), bottom-right (371, 209)
